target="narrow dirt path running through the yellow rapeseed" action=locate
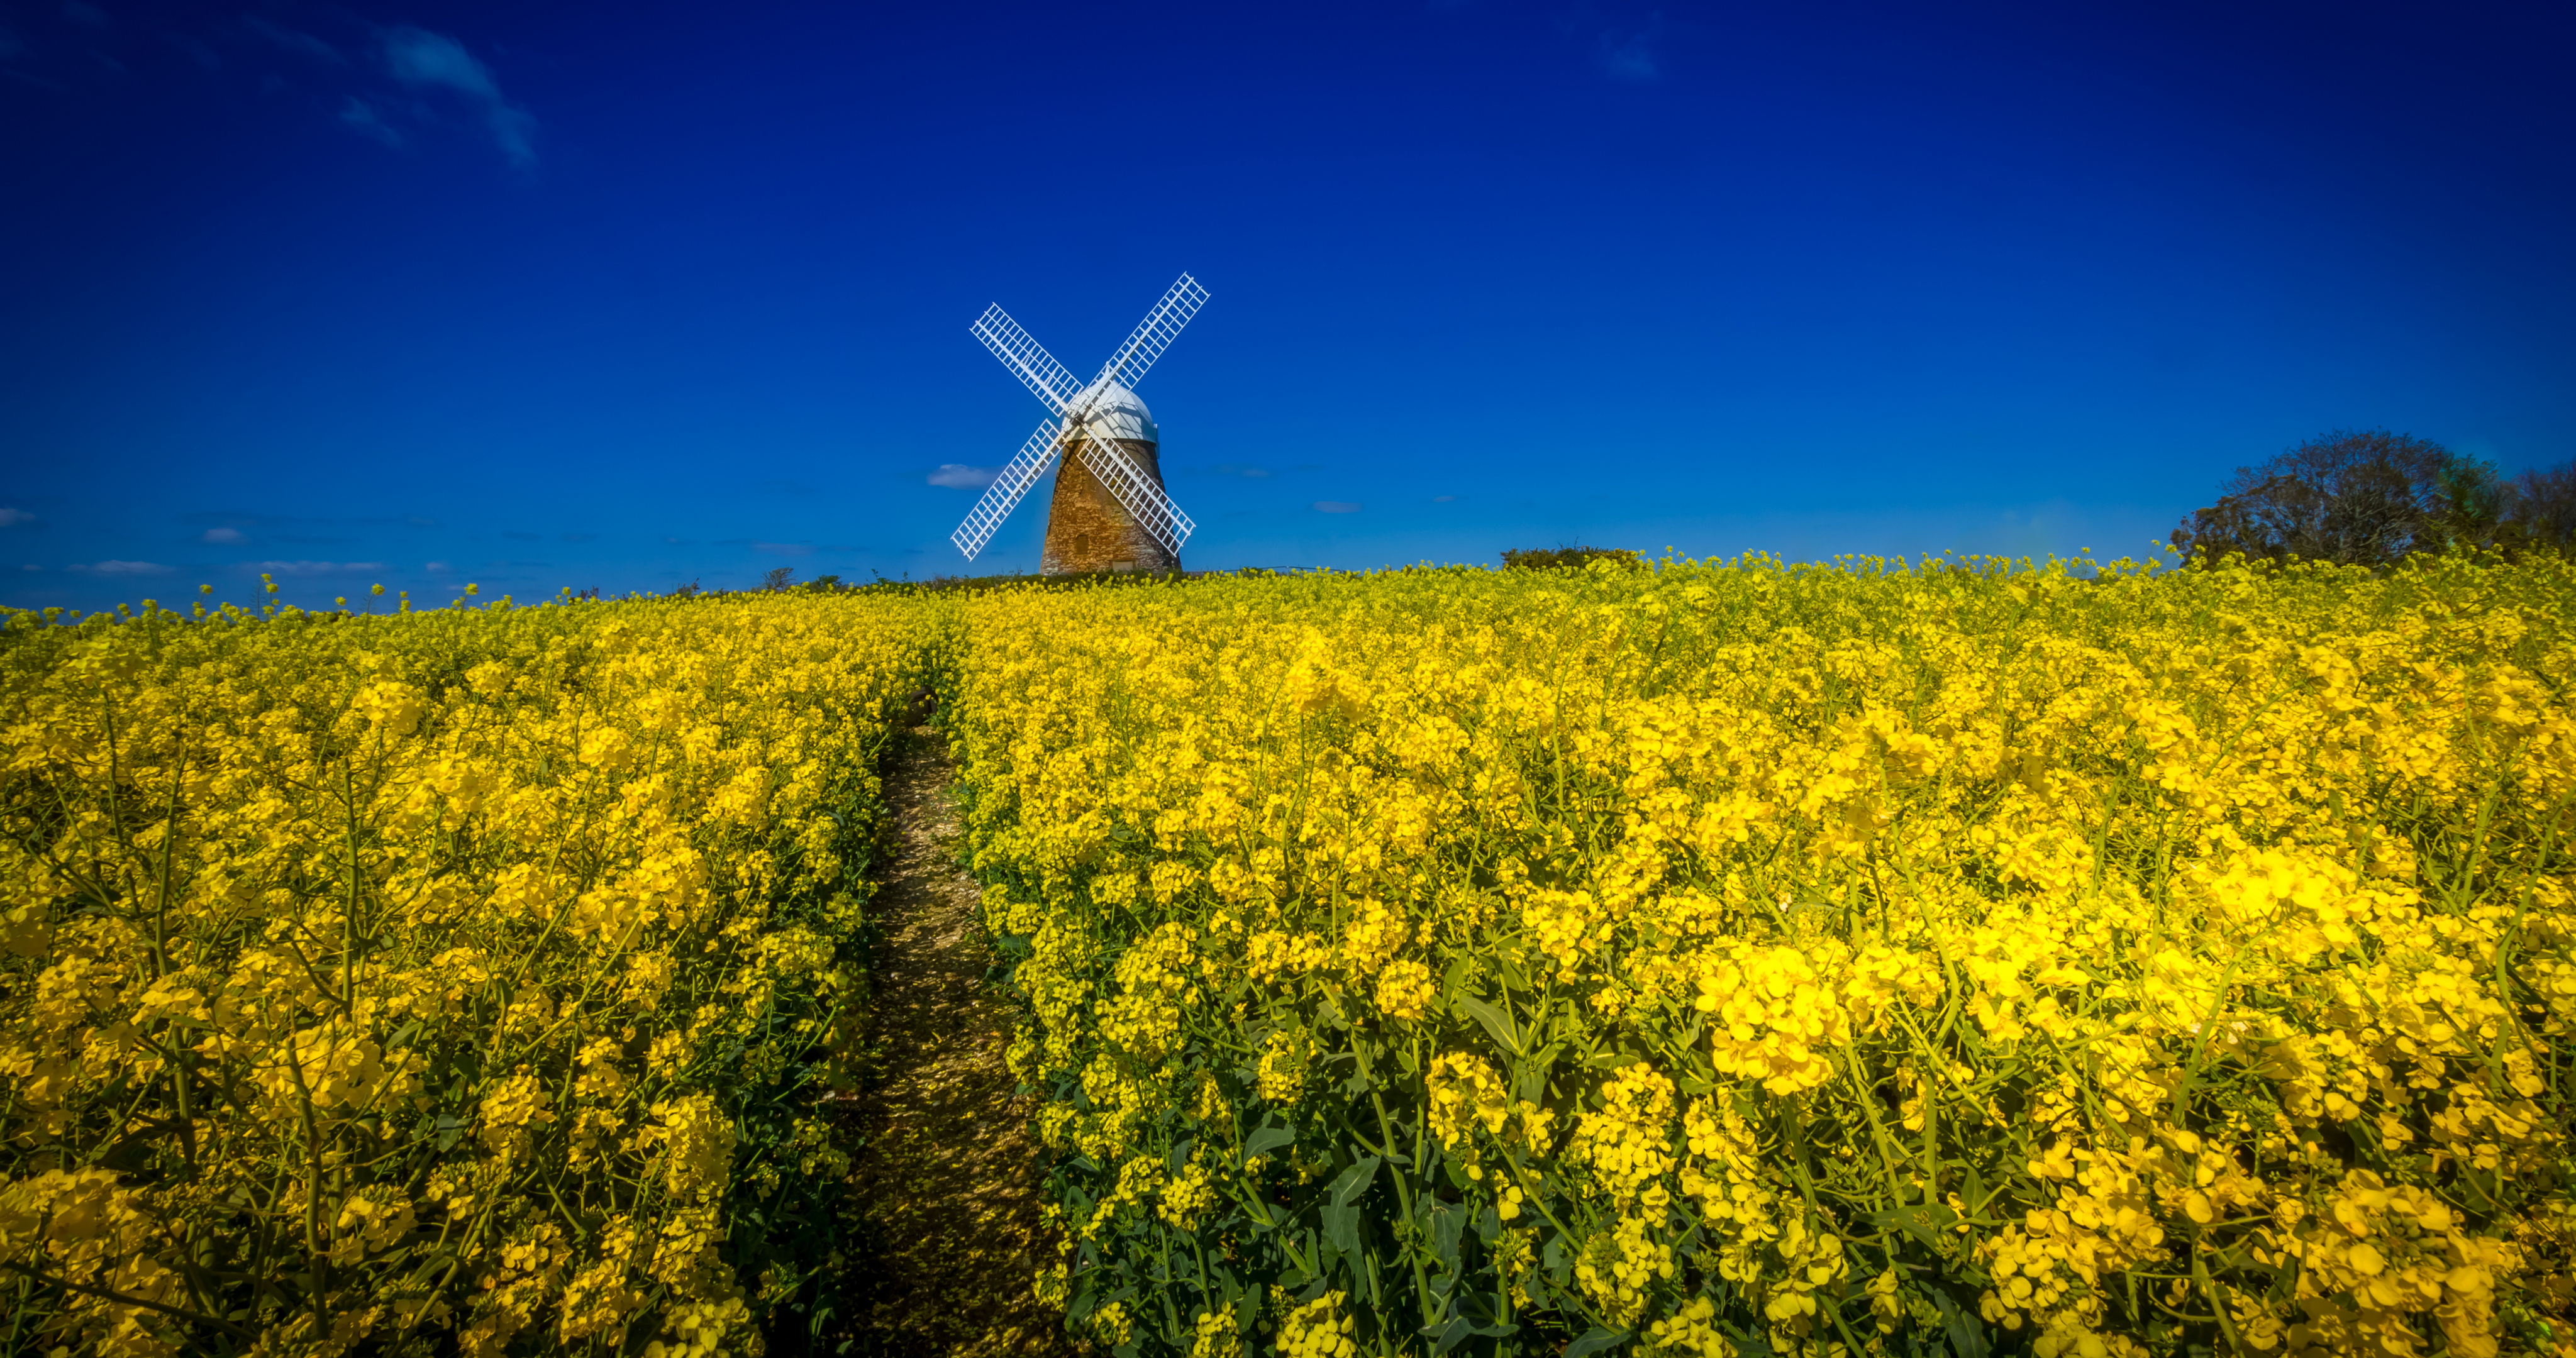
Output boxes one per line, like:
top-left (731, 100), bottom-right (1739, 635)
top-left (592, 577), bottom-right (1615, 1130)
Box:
top-left (824, 727), bottom-right (1077, 1358)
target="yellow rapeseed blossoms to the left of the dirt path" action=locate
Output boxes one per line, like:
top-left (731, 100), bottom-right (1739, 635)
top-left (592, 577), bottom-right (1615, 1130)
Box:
top-left (0, 598), bottom-right (930, 1358)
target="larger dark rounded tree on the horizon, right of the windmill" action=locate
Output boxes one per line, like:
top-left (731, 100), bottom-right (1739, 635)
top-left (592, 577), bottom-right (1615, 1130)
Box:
top-left (2174, 430), bottom-right (2506, 567)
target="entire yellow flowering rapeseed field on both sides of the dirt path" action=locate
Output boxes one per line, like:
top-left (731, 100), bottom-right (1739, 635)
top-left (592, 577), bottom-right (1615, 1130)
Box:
top-left (0, 556), bottom-right (2576, 1358)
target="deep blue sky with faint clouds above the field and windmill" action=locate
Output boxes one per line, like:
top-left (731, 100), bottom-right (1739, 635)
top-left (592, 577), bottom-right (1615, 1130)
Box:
top-left (0, 0), bottom-right (2576, 608)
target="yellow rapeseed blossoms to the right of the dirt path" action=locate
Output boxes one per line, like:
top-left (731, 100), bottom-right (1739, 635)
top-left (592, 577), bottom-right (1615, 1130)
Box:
top-left (948, 556), bottom-right (2576, 1358)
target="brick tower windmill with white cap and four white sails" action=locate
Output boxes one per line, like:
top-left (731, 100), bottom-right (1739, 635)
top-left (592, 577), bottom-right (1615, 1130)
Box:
top-left (948, 273), bottom-right (1208, 575)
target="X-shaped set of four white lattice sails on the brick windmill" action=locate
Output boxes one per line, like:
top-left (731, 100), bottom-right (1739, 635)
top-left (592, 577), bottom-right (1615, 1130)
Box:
top-left (948, 273), bottom-right (1208, 562)
